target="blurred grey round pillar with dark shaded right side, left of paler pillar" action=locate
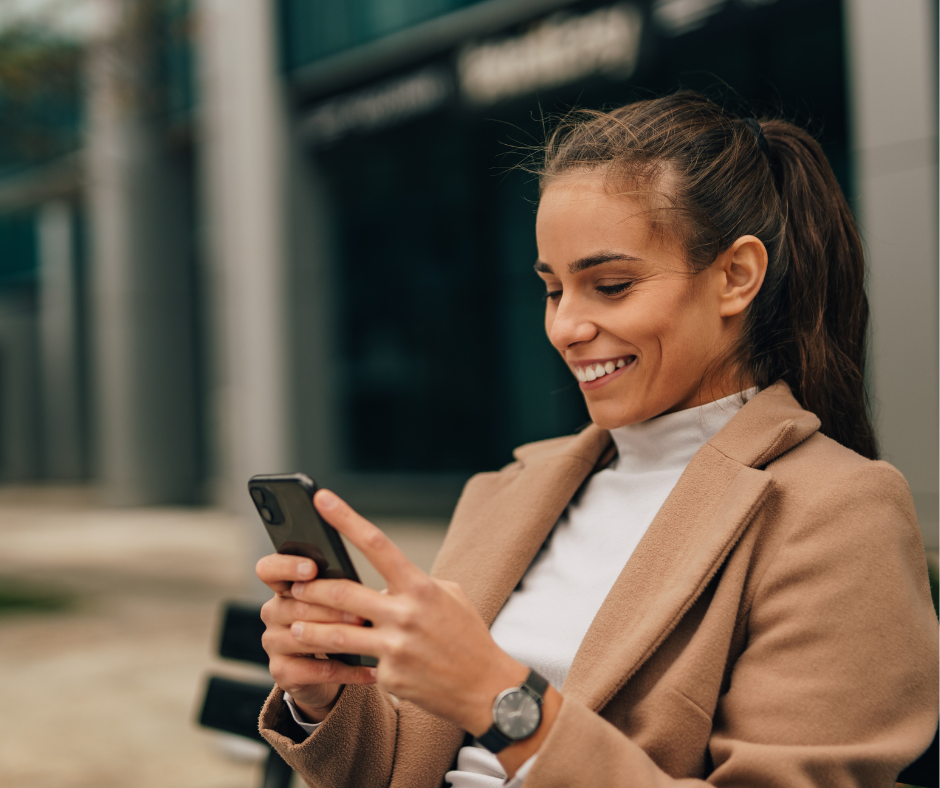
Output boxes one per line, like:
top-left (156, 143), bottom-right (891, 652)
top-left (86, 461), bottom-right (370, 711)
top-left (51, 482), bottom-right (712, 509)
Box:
top-left (86, 0), bottom-right (199, 505)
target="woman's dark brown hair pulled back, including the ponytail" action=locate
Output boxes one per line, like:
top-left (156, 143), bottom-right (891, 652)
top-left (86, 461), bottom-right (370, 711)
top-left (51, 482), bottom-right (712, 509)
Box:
top-left (538, 92), bottom-right (877, 459)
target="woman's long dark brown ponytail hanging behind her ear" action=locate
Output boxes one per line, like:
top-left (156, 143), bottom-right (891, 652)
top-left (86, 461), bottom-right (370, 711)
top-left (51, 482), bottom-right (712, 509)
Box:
top-left (751, 120), bottom-right (878, 459)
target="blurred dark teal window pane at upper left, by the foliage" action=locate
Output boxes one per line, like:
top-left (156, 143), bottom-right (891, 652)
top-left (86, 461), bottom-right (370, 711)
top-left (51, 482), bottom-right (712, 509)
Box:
top-left (0, 27), bottom-right (81, 175)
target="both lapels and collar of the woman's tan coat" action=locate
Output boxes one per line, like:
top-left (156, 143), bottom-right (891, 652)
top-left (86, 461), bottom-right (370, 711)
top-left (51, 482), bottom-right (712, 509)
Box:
top-left (435, 383), bottom-right (819, 710)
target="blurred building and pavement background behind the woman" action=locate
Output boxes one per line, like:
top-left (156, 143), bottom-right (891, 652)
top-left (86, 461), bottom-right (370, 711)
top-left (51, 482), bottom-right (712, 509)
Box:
top-left (0, 0), bottom-right (938, 788)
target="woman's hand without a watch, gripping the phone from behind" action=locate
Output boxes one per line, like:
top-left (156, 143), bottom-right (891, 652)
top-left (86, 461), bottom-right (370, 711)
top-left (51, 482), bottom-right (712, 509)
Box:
top-left (255, 553), bottom-right (375, 722)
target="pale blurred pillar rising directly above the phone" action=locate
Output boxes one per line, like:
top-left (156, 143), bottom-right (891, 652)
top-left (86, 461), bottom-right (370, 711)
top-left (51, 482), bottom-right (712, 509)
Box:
top-left (199, 0), bottom-right (292, 580)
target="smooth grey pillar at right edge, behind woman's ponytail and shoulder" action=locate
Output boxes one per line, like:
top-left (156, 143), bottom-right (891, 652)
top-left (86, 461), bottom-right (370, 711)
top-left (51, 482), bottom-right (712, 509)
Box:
top-left (845, 0), bottom-right (938, 549)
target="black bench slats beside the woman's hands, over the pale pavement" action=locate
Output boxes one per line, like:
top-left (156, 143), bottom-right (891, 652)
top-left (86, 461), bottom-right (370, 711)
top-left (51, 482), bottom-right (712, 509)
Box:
top-left (199, 602), bottom-right (293, 788)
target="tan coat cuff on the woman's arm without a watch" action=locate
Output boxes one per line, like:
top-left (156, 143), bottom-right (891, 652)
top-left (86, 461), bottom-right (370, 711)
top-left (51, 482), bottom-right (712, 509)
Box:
top-left (259, 684), bottom-right (398, 788)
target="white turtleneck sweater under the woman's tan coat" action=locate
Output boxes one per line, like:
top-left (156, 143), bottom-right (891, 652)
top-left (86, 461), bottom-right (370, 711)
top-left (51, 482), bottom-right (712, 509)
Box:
top-left (285, 389), bottom-right (757, 788)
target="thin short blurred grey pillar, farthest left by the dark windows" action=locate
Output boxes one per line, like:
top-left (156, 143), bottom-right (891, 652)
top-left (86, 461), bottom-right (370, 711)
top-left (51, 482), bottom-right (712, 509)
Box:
top-left (37, 200), bottom-right (84, 480)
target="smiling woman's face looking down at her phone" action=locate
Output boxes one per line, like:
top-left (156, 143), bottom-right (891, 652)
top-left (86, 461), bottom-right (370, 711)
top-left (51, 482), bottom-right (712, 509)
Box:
top-left (536, 175), bottom-right (733, 429)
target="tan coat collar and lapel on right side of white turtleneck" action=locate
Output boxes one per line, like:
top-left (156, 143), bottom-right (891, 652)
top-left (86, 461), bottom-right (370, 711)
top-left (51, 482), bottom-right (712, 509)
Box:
top-left (563, 384), bottom-right (819, 710)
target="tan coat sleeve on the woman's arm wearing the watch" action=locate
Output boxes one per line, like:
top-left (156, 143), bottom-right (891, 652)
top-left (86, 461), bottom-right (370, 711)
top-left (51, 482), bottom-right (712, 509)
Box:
top-left (525, 463), bottom-right (938, 788)
